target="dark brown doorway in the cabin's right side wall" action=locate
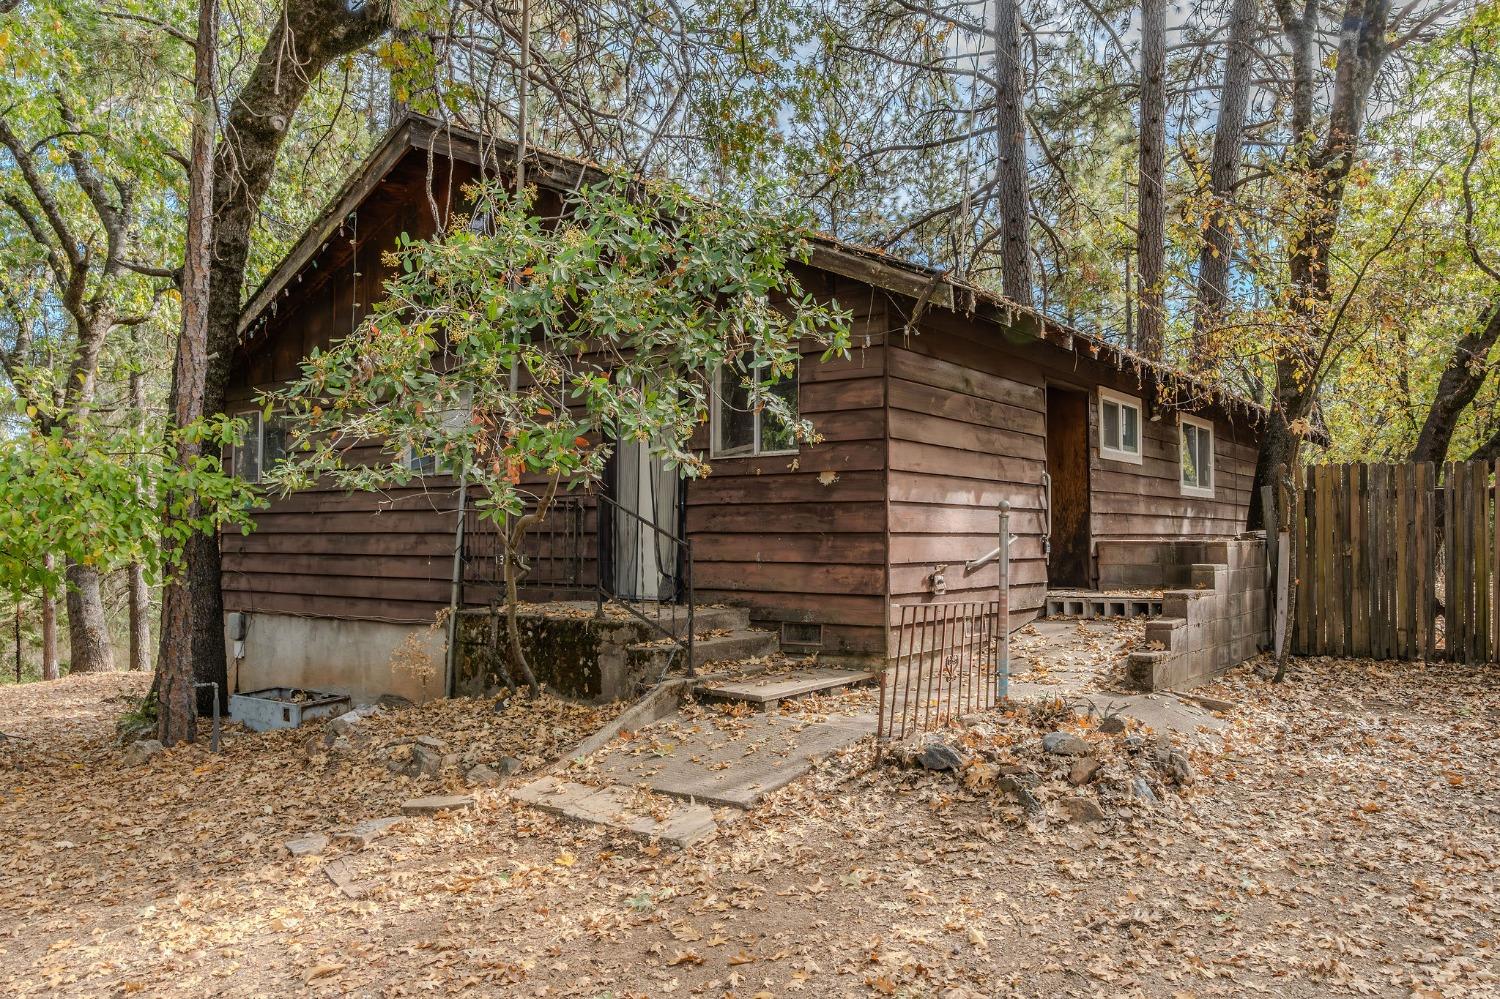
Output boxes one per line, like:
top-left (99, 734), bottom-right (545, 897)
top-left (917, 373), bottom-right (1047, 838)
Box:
top-left (1047, 386), bottom-right (1091, 588)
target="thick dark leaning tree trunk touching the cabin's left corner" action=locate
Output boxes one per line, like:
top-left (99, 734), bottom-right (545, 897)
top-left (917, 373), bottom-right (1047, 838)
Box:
top-left (177, 0), bottom-right (395, 717)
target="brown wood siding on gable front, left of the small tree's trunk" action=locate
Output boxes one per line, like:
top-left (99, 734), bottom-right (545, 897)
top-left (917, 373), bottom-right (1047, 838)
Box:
top-left (221, 153), bottom-right (473, 623)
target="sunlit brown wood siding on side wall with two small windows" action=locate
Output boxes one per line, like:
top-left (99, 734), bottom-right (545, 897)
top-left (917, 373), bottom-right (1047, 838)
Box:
top-left (887, 314), bottom-right (1256, 618)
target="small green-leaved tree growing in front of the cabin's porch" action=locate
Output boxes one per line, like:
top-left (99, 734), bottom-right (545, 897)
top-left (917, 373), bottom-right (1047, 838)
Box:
top-left (266, 177), bottom-right (849, 692)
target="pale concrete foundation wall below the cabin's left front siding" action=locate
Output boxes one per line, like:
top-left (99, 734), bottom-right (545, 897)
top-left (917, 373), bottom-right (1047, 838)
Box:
top-left (225, 614), bottom-right (447, 704)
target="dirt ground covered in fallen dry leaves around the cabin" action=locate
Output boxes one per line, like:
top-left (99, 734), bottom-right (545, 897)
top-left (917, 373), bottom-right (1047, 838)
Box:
top-left (0, 660), bottom-right (1500, 999)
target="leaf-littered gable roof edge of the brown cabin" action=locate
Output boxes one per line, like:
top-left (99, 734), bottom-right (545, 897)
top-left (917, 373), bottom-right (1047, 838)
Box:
top-left (237, 114), bottom-right (1268, 422)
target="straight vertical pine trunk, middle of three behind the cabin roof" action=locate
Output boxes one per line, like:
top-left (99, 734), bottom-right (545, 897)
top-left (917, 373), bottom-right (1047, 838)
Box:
top-left (1136, 0), bottom-right (1167, 360)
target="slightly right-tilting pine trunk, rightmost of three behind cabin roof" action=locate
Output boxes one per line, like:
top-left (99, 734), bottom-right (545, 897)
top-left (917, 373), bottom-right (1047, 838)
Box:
top-left (1193, 0), bottom-right (1256, 361)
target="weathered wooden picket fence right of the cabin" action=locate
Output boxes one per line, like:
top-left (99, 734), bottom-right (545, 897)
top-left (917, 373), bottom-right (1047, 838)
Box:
top-left (1280, 462), bottom-right (1500, 663)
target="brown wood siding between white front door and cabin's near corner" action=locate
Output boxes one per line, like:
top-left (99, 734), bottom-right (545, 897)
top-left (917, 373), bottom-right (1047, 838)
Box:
top-left (687, 281), bottom-right (887, 654)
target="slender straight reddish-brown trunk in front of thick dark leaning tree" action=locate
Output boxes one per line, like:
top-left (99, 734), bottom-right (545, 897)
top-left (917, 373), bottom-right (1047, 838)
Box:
top-left (156, 0), bottom-right (224, 746)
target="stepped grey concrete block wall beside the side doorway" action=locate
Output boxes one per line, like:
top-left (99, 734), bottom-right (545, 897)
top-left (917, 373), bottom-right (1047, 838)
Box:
top-left (1128, 534), bottom-right (1271, 690)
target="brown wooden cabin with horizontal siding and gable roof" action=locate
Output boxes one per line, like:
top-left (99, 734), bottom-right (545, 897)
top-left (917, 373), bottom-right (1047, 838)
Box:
top-left (222, 119), bottom-right (1263, 701)
